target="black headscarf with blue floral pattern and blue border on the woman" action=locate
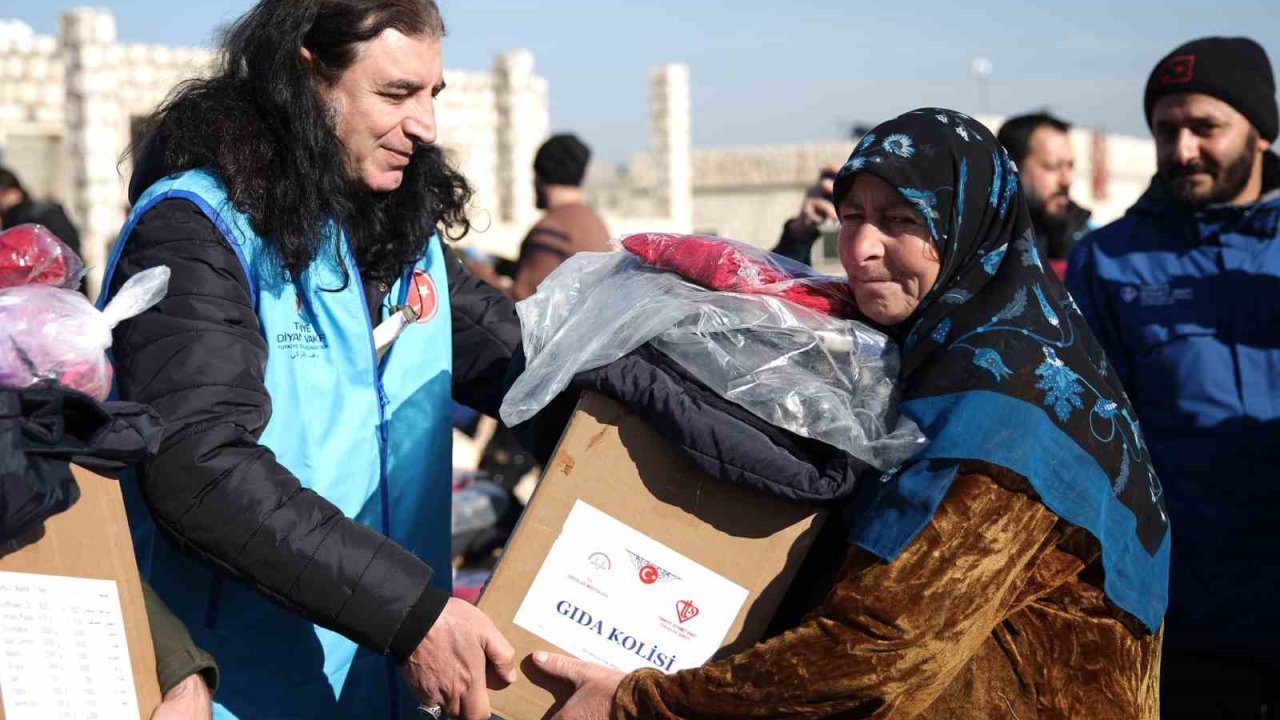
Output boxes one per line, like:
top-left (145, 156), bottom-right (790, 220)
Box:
top-left (835, 109), bottom-right (1170, 632)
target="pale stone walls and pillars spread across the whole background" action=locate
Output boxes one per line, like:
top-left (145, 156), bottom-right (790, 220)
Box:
top-left (0, 9), bottom-right (1156, 288)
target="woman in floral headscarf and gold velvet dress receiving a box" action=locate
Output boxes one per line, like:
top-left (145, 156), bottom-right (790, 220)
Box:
top-left (535, 109), bottom-right (1169, 720)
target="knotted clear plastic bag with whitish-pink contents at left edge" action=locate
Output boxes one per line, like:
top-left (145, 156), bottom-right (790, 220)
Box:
top-left (0, 266), bottom-right (169, 400)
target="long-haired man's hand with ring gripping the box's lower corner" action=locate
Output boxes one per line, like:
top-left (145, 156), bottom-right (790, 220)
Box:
top-left (402, 597), bottom-right (516, 720)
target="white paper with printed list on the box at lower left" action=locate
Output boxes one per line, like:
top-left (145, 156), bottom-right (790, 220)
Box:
top-left (0, 571), bottom-right (138, 720)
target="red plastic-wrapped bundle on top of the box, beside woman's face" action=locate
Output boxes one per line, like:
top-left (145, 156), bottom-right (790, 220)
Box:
top-left (622, 232), bottom-right (861, 319)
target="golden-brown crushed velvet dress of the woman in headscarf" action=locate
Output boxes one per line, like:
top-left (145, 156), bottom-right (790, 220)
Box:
top-left (612, 462), bottom-right (1160, 720)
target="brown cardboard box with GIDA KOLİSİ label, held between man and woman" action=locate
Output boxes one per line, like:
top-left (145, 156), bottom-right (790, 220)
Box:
top-left (479, 393), bottom-right (823, 720)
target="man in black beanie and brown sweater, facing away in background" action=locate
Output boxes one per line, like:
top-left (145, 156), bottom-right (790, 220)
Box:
top-left (511, 135), bottom-right (609, 300)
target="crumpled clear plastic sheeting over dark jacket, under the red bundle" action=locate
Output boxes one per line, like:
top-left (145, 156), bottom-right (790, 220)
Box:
top-left (500, 252), bottom-right (924, 469)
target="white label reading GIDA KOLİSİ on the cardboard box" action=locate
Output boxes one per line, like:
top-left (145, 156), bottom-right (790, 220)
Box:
top-left (515, 500), bottom-right (748, 673)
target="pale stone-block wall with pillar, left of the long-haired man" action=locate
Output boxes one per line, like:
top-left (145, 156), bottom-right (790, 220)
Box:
top-left (0, 10), bottom-right (212, 287)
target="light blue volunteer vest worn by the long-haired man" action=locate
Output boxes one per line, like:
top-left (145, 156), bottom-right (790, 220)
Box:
top-left (100, 170), bottom-right (452, 719)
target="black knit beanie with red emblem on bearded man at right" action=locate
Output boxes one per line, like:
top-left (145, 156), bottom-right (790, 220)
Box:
top-left (1143, 37), bottom-right (1280, 141)
